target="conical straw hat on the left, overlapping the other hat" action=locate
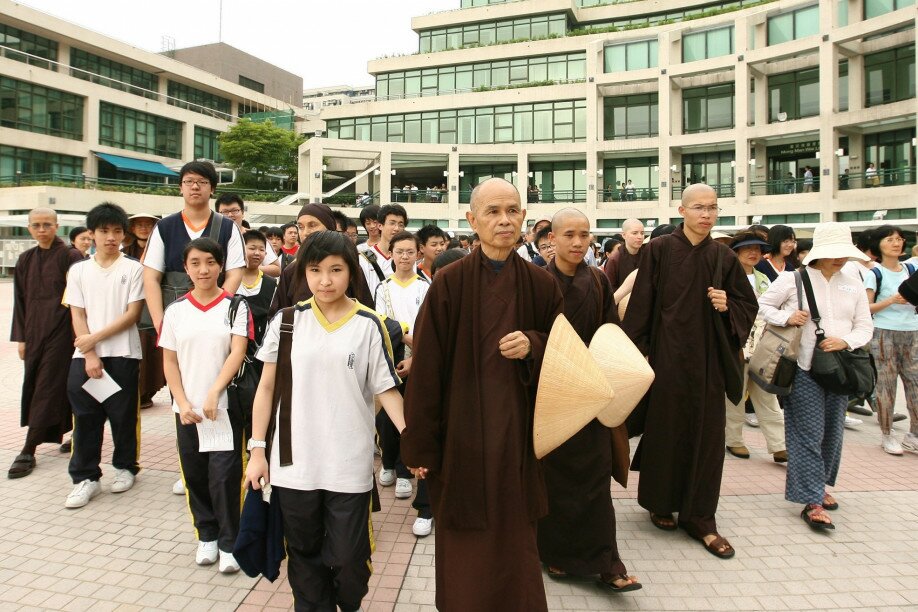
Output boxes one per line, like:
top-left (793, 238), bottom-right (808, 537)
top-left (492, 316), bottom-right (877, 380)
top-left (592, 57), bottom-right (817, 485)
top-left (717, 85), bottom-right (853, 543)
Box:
top-left (532, 315), bottom-right (614, 459)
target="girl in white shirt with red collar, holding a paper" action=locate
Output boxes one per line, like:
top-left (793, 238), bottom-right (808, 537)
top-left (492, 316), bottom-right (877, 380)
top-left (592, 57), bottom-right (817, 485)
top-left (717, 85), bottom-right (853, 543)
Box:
top-left (159, 238), bottom-right (254, 573)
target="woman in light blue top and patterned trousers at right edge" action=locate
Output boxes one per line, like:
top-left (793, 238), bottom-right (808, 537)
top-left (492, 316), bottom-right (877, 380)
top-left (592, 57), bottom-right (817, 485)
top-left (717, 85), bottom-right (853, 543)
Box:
top-left (864, 225), bottom-right (918, 455)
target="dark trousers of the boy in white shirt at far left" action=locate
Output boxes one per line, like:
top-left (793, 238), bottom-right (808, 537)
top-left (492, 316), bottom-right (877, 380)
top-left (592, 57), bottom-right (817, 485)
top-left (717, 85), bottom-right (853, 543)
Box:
top-left (67, 357), bottom-right (140, 484)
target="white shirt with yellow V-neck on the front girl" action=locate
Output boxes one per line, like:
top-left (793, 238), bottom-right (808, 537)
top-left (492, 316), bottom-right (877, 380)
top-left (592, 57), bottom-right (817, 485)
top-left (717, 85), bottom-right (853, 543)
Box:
top-left (257, 298), bottom-right (401, 493)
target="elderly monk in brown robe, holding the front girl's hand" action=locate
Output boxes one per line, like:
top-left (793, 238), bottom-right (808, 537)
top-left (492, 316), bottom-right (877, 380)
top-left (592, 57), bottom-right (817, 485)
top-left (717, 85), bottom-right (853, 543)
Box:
top-left (402, 178), bottom-right (561, 612)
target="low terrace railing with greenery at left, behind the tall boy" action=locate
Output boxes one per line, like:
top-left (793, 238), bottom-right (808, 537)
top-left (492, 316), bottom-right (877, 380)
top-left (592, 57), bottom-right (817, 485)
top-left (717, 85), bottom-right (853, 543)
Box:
top-left (0, 172), bottom-right (293, 202)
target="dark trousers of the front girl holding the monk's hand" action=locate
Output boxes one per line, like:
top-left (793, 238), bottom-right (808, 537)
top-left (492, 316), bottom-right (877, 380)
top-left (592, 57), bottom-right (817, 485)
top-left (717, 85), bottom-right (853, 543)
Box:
top-left (274, 487), bottom-right (373, 612)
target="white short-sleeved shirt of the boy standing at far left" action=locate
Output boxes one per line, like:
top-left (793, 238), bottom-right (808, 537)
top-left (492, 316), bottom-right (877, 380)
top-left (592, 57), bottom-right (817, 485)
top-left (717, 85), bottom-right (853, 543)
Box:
top-left (64, 253), bottom-right (144, 359)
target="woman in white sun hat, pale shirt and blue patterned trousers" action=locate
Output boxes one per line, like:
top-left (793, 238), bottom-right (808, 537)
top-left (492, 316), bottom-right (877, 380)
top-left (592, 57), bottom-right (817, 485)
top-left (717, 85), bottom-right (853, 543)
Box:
top-left (759, 222), bottom-right (873, 530)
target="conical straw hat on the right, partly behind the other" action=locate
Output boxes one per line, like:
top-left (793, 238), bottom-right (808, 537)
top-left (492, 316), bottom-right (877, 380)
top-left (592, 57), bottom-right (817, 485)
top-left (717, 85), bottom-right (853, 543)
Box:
top-left (590, 323), bottom-right (653, 427)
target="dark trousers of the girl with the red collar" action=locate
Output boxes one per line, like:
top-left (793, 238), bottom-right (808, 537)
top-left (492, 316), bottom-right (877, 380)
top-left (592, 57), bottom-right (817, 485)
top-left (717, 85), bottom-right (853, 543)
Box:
top-left (175, 410), bottom-right (243, 552)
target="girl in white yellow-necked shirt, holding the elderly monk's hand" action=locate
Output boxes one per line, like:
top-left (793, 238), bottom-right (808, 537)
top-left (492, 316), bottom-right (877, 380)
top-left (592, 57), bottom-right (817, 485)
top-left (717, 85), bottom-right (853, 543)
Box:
top-left (246, 232), bottom-right (405, 610)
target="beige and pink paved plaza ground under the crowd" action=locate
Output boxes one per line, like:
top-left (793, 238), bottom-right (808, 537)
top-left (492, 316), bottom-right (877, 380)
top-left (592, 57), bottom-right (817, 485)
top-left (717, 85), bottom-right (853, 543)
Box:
top-left (0, 282), bottom-right (918, 612)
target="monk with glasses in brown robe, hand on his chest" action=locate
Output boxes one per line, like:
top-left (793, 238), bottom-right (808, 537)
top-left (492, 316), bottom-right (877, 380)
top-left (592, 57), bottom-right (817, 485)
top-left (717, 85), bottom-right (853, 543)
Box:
top-left (622, 183), bottom-right (758, 558)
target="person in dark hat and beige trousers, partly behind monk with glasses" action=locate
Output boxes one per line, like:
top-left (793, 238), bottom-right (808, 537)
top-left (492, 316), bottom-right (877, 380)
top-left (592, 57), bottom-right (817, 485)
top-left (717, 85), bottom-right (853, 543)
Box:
top-left (725, 230), bottom-right (787, 463)
